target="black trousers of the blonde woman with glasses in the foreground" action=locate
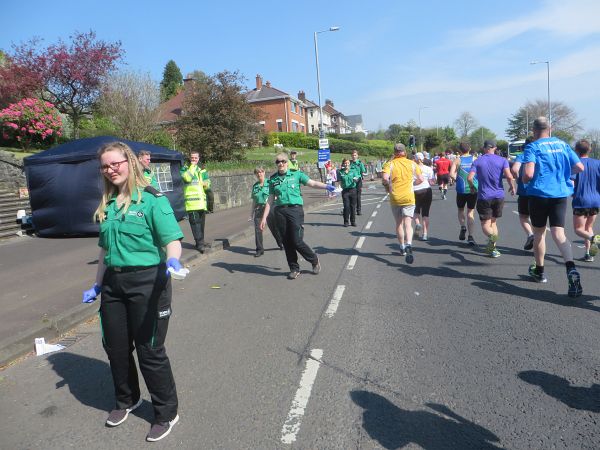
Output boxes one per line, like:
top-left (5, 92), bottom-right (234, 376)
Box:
top-left (99, 264), bottom-right (178, 422)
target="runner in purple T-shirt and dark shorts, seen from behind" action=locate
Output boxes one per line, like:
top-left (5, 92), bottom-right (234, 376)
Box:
top-left (467, 140), bottom-right (515, 258)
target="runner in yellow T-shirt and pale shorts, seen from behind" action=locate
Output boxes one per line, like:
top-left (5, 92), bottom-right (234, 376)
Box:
top-left (382, 143), bottom-right (423, 264)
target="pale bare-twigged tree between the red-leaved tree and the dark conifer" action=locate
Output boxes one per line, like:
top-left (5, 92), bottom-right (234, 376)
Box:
top-left (98, 72), bottom-right (160, 141)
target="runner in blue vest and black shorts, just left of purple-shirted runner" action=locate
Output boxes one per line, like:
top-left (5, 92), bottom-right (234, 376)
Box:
top-left (450, 142), bottom-right (478, 245)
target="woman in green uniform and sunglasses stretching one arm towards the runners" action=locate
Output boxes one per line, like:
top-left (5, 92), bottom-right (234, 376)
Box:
top-left (260, 153), bottom-right (335, 280)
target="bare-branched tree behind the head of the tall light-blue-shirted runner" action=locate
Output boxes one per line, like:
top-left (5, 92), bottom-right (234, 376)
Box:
top-left (506, 100), bottom-right (582, 140)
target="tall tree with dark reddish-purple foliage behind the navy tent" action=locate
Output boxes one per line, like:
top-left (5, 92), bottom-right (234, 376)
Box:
top-left (10, 31), bottom-right (123, 137)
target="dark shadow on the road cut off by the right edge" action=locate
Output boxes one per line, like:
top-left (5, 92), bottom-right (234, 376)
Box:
top-left (519, 370), bottom-right (600, 413)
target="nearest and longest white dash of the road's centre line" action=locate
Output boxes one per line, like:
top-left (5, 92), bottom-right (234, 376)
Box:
top-left (281, 349), bottom-right (323, 444)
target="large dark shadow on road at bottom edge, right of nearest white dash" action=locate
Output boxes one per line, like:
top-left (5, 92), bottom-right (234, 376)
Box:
top-left (350, 390), bottom-right (501, 450)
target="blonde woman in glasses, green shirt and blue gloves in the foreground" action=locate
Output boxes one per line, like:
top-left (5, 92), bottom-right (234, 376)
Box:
top-left (83, 142), bottom-right (183, 441)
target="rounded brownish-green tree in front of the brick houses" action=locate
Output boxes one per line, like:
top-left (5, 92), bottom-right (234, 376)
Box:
top-left (176, 71), bottom-right (260, 161)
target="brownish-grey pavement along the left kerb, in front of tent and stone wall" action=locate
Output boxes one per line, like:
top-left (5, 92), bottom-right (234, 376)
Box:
top-left (0, 183), bottom-right (346, 367)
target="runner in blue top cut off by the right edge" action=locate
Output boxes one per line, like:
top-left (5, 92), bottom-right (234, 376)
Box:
top-left (573, 139), bottom-right (600, 262)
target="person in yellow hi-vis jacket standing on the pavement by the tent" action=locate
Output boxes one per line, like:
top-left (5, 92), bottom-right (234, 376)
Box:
top-left (181, 151), bottom-right (210, 253)
